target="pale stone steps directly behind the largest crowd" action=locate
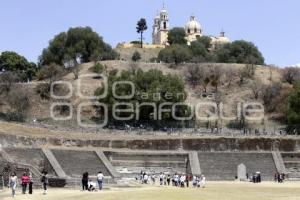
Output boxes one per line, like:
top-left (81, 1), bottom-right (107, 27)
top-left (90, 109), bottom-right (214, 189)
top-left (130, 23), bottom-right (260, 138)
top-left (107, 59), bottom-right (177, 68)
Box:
top-left (105, 152), bottom-right (188, 178)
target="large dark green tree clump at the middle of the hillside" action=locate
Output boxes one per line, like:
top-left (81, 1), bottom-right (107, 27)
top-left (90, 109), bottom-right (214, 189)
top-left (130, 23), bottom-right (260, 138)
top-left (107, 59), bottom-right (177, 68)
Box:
top-left (95, 69), bottom-right (188, 127)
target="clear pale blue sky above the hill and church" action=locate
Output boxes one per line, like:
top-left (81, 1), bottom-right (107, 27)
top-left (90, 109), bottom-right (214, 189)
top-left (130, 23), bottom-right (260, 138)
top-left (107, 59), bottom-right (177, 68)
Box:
top-left (0, 0), bottom-right (300, 66)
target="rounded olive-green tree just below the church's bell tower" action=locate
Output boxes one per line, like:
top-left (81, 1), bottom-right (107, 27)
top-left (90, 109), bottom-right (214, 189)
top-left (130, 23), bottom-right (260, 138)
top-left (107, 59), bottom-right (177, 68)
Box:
top-left (158, 44), bottom-right (192, 65)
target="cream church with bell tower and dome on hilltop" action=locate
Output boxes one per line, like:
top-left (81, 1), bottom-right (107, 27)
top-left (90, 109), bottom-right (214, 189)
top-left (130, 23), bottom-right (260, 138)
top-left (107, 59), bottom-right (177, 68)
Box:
top-left (152, 6), bottom-right (230, 48)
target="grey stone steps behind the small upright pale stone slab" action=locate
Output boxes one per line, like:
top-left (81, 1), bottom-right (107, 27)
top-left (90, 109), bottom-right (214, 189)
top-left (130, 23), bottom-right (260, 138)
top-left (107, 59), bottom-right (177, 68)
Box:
top-left (198, 152), bottom-right (276, 181)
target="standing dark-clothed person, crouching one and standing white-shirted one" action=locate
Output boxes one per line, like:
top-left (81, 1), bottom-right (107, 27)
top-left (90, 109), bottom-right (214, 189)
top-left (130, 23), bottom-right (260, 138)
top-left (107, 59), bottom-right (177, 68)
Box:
top-left (81, 171), bottom-right (104, 191)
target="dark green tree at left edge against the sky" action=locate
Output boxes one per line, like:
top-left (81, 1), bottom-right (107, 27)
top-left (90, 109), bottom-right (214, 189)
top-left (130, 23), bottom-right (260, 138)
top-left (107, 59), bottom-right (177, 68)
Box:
top-left (0, 51), bottom-right (37, 81)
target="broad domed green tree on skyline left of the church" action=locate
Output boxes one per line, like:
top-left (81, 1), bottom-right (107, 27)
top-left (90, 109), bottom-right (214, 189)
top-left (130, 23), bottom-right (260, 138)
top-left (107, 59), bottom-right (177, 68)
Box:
top-left (39, 27), bottom-right (117, 66)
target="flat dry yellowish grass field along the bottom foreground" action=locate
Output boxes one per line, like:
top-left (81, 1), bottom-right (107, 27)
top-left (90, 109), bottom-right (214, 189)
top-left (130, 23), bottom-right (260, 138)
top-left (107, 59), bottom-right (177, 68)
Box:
top-left (0, 182), bottom-right (300, 200)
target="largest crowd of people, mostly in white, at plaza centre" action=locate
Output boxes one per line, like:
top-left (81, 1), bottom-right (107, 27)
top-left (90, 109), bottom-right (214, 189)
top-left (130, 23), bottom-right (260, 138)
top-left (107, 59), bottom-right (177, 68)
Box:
top-left (140, 171), bottom-right (206, 188)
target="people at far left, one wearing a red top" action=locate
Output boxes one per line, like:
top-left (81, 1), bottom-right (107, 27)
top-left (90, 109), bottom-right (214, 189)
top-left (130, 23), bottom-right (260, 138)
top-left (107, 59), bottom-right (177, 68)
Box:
top-left (8, 172), bottom-right (49, 197)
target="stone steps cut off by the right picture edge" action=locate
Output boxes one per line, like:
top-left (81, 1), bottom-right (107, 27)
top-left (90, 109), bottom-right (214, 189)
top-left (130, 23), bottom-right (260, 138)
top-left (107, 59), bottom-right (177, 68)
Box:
top-left (281, 152), bottom-right (300, 181)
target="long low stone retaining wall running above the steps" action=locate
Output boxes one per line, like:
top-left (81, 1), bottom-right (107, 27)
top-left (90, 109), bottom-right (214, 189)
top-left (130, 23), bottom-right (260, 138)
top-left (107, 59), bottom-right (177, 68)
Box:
top-left (0, 134), bottom-right (300, 152)
